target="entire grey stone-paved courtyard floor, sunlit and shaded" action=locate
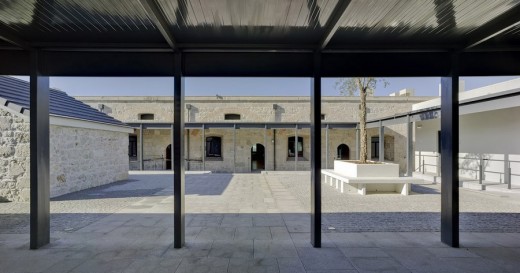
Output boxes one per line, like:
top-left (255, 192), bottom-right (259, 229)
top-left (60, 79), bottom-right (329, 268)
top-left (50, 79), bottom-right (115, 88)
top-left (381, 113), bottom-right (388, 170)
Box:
top-left (0, 172), bottom-right (520, 273)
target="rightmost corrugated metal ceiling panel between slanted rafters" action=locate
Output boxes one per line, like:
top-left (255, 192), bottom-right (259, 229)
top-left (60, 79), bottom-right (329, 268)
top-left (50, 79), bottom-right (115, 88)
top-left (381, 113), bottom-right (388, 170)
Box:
top-left (330, 0), bottom-right (519, 47)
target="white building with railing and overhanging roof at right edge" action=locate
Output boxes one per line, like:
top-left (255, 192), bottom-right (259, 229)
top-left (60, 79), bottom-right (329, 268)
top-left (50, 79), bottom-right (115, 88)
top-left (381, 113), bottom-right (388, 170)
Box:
top-left (412, 79), bottom-right (520, 189)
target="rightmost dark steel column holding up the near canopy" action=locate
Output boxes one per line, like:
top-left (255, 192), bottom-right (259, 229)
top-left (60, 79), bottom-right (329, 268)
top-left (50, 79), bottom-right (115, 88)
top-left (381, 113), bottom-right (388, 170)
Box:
top-left (441, 53), bottom-right (459, 247)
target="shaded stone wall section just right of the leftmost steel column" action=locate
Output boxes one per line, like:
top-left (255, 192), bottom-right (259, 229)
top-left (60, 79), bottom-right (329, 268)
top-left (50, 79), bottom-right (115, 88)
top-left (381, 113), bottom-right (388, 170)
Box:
top-left (50, 125), bottom-right (129, 197)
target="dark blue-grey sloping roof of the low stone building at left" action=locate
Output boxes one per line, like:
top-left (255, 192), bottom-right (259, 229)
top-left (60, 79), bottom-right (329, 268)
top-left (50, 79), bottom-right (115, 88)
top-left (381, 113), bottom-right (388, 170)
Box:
top-left (0, 76), bottom-right (126, 126)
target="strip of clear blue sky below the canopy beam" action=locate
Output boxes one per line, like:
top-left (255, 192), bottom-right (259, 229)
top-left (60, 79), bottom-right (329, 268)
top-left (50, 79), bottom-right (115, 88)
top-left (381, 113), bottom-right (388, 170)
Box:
top-left (12, 76), bottom-right (518, 96)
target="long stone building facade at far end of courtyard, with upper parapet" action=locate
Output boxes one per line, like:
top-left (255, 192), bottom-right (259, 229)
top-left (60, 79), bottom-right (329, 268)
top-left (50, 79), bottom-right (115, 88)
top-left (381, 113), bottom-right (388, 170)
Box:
top-left (77, 96), bottom-right (431, 172)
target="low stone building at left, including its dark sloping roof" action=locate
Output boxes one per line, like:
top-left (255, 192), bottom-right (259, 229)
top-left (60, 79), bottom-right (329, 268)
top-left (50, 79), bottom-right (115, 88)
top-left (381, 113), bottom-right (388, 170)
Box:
top-left (0, 77), bottom-right (133, 202)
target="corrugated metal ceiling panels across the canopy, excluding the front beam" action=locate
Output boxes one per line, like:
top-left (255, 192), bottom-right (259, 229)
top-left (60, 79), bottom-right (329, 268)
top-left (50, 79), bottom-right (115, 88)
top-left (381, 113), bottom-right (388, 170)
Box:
top-left (0, 0), bottom-right (520, 48)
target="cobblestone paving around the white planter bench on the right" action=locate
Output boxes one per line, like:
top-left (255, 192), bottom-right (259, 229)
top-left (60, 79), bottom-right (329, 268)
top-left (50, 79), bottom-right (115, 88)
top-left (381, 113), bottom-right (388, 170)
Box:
top-left (274, 172), bottom-right (520, 232)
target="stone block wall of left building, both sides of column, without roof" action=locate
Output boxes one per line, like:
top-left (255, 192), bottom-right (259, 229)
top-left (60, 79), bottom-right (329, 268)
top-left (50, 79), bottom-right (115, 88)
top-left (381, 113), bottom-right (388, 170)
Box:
top-left (0, 105), bottom-right (129, 202)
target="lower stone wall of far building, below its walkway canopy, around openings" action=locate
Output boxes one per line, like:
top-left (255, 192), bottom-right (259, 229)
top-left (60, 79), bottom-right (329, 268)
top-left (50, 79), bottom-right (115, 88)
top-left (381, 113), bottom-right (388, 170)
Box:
top-left (138, 125), bottom-right (407, 174)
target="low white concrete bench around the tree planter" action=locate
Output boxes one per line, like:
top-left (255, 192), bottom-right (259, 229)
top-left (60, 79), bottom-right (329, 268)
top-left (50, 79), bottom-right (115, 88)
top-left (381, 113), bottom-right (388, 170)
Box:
top-left (321, 170), bottom-right (424, 195)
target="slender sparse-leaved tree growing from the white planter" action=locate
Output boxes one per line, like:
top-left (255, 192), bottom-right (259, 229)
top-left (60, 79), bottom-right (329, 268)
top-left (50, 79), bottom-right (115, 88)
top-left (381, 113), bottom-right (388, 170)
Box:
top-left (336, 78), bottom-right (388, 163)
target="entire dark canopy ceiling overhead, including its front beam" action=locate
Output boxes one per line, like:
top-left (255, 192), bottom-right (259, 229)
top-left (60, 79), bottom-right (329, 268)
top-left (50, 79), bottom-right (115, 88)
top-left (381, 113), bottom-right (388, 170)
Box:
top-left (0, 0), bottom-right (520, 76)
